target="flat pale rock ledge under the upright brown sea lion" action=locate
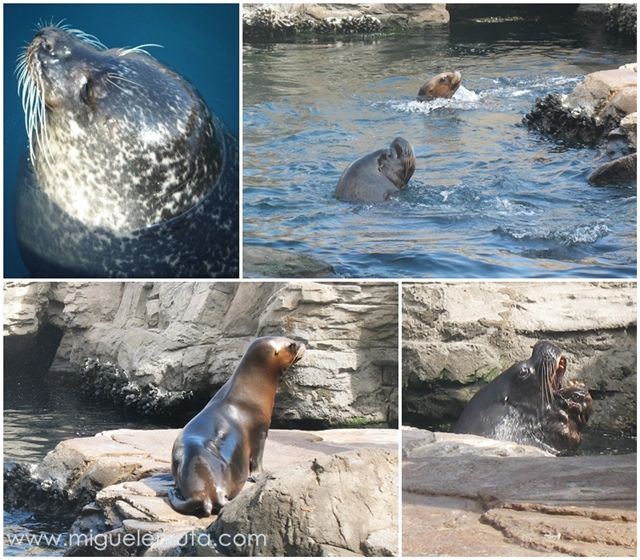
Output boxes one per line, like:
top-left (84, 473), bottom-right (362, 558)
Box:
top-left (5, 429), bottom-right (399, 556)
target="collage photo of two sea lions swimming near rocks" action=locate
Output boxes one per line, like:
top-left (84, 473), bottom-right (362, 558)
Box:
top-left (242, 3), bottom-right (637, 279)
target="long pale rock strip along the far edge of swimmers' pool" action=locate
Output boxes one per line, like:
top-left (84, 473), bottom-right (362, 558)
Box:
top-left (242, 4), bottom-right (449, 38)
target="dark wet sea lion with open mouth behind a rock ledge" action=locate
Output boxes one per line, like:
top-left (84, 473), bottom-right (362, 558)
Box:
top-left (454, 340), bottom-right (592, 452)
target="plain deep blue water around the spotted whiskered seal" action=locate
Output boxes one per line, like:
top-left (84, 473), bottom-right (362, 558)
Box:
top-left (3, 4), bottom-right (239, 278)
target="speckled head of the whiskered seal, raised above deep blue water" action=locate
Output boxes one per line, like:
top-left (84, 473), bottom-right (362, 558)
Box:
top-left (17, 25), bottom-right (223, 233)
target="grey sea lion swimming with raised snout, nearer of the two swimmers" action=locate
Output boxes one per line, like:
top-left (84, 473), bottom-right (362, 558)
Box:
top-left (336, 137), bottom-right (416, 202)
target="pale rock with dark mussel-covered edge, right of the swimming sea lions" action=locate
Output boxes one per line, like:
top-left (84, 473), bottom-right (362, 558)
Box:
top-left (523, 65), bottom-right (637, 146)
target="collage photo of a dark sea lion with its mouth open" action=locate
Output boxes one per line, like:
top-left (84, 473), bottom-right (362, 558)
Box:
top-left (402, 282), bottom-right (637, 557)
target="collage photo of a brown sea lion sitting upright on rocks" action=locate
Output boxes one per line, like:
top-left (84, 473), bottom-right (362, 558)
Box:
top-left (4, 282), bottom-right (399, 556)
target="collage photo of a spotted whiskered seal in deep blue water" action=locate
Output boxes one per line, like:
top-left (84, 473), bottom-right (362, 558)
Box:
top-left (3, 4), bottom-right (240, 279)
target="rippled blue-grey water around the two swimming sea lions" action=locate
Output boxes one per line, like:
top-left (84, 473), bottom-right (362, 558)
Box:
top-left (243, 23), bottom-right (636, 277)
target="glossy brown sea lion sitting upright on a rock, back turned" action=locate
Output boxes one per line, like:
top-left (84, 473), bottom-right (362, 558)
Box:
top-left (169, 337), bottom-right (305, 517)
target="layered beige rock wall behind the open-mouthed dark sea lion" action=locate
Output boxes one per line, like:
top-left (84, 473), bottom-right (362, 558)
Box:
top-left (402, 282), bottom-right (637, 432)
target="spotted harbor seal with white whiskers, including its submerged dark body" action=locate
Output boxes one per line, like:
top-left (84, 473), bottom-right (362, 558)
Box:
top-left (16, 25), bottom-right (239, 278)
